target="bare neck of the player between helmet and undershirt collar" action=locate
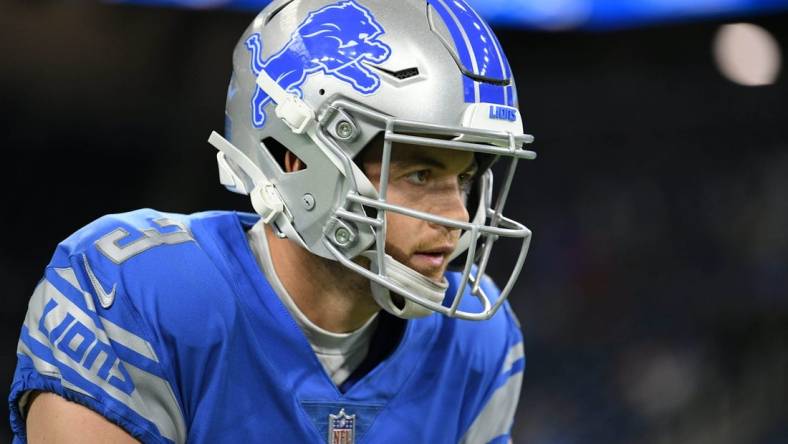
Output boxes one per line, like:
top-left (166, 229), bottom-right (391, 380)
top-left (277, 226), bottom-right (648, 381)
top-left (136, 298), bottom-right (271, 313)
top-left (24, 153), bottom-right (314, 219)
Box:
top-left (265, 227), bottom-right (380, 333)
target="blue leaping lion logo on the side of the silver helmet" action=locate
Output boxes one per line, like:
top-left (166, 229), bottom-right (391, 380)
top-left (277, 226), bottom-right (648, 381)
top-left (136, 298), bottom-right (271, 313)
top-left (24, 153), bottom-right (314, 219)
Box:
top-left (246, 0), bottom-right (391, 128)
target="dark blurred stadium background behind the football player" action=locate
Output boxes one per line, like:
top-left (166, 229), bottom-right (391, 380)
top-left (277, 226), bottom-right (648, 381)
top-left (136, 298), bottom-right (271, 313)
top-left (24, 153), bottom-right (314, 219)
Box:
top-left (0, 0), bottom-right (788, 444)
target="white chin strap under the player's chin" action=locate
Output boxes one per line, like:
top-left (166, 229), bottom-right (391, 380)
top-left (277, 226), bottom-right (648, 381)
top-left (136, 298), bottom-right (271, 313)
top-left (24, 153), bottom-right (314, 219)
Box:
top-left (361, 250), bottom-right (449, 319)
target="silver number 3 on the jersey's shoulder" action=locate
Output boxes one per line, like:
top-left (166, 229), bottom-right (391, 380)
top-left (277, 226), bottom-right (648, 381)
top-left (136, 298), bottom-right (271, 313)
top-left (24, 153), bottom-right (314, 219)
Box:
top-left (96, 219), bottom-right (194, 264)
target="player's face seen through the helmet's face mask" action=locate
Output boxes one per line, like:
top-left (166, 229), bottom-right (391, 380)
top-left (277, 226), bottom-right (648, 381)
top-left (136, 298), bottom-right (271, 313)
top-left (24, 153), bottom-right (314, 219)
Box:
top-left (362, 144), bottom-right (476, 281)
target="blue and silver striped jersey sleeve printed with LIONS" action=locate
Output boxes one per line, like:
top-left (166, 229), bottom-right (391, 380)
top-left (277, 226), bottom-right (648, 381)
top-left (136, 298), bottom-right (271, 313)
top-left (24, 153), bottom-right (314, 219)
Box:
top-left (12, 268), bottom-right (186, 442)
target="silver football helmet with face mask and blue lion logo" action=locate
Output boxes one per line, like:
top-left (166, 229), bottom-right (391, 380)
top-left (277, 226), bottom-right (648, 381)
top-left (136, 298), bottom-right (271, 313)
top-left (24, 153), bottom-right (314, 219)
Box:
top-left (209, 0), bottom-right (536, 320)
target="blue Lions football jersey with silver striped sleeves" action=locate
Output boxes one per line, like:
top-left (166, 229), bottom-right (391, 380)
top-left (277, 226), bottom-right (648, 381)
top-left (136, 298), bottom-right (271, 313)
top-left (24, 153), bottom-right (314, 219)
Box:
top-left (10, 210), bottom-right (525, 443)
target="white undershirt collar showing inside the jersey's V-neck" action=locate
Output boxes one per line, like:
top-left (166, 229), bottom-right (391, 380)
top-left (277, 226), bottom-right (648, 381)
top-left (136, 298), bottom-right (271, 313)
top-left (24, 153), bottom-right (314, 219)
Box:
top-left (246, 221), bottom-right (378, 386)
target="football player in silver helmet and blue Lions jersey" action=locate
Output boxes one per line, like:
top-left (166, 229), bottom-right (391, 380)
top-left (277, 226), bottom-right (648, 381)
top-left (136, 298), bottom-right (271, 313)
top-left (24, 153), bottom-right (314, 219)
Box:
top-left (10, 0), bottom-right (535, 443)
